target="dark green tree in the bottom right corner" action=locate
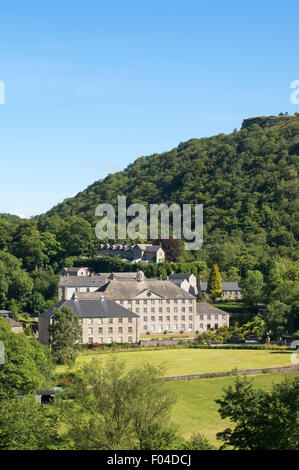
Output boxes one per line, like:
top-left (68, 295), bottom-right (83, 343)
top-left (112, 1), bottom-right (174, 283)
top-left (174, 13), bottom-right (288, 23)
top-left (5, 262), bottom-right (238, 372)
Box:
top-left (216, 377), bottom-right (299, 450)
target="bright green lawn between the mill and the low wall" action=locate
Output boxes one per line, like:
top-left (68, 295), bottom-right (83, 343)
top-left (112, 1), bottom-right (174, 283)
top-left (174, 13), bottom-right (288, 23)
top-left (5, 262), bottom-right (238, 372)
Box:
top-left (57, 348), bottom-right (291, 376)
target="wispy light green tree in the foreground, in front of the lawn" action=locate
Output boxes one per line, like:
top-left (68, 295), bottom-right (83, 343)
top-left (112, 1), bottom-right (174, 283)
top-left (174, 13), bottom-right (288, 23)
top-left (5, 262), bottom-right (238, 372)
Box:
top-left (58, 360), bottom-right (175, 450)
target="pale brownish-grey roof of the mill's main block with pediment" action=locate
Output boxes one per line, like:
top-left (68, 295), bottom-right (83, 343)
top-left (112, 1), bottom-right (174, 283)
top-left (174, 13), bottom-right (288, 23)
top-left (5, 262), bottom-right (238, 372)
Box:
top-left (78, 279), bottom-right (195, 300)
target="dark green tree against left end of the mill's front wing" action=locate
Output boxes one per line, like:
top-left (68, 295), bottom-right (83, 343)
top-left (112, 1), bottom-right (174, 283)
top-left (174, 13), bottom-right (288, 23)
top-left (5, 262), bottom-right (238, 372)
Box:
top-left (49, 306), bottom-right (82, 364)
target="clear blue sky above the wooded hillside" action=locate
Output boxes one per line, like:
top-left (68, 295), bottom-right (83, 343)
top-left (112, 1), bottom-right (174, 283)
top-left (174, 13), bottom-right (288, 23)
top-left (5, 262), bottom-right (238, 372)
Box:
top-left (0, 0), bottom-right (299, 217)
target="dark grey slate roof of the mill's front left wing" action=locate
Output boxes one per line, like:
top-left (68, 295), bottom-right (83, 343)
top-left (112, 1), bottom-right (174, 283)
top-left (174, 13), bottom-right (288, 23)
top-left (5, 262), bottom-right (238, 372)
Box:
top-left (40, 299), bottom-right (138, 318)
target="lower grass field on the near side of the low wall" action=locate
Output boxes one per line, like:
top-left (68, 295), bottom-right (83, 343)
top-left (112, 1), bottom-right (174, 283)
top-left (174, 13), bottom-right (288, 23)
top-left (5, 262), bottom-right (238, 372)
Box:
top-left (167, 371), bottom-right (299, 447)
